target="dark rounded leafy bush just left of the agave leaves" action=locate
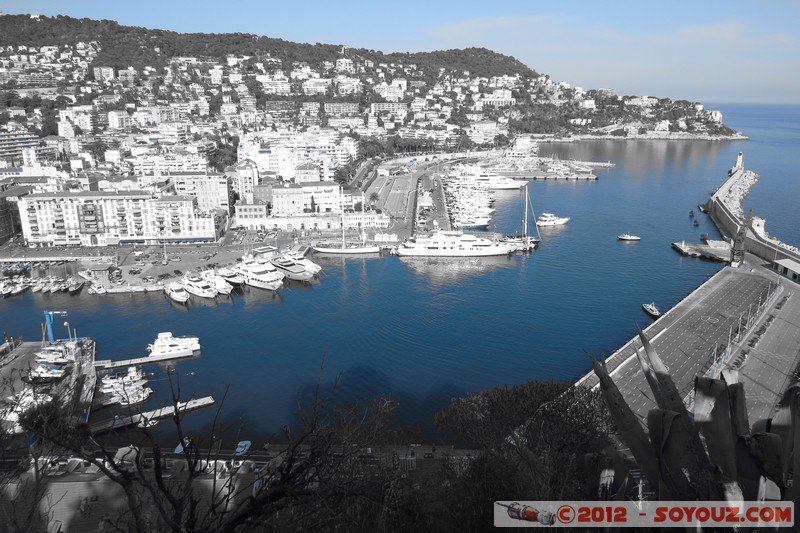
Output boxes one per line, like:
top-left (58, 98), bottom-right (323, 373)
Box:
top-left (432, 381), bottom-right (610, 531)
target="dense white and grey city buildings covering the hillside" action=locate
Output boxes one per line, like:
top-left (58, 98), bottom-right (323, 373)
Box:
top-left (0, 13), bottom-right (730, 245)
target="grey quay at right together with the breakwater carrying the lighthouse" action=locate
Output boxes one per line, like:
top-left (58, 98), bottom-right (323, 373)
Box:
top-left (577, 153), bottom-right (800, 423)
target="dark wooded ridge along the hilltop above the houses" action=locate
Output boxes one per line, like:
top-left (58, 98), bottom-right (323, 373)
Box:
top-left (0, 15), bottom-right (536, 77)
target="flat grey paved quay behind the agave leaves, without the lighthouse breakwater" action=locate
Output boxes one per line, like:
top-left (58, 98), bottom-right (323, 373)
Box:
top-left (578, 267), bottom-right (800, 422)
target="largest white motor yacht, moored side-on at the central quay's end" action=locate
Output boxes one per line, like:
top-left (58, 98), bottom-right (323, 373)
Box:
top-left (395, 231), bottom-right (516, 257)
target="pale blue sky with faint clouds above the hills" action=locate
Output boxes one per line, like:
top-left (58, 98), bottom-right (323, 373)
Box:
top-left (0, 0), bottom-right (800, 103)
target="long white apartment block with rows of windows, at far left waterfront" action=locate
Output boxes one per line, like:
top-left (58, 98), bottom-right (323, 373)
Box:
top-left (17, 191), bottom-right (217, 246)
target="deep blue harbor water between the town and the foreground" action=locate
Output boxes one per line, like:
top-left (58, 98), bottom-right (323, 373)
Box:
top-left (0, 105), bottom-right (800, 439)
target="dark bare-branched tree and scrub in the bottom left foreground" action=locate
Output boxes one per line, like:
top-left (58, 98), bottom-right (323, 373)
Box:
top-left (12, 360), bottom-right (418, 532)
